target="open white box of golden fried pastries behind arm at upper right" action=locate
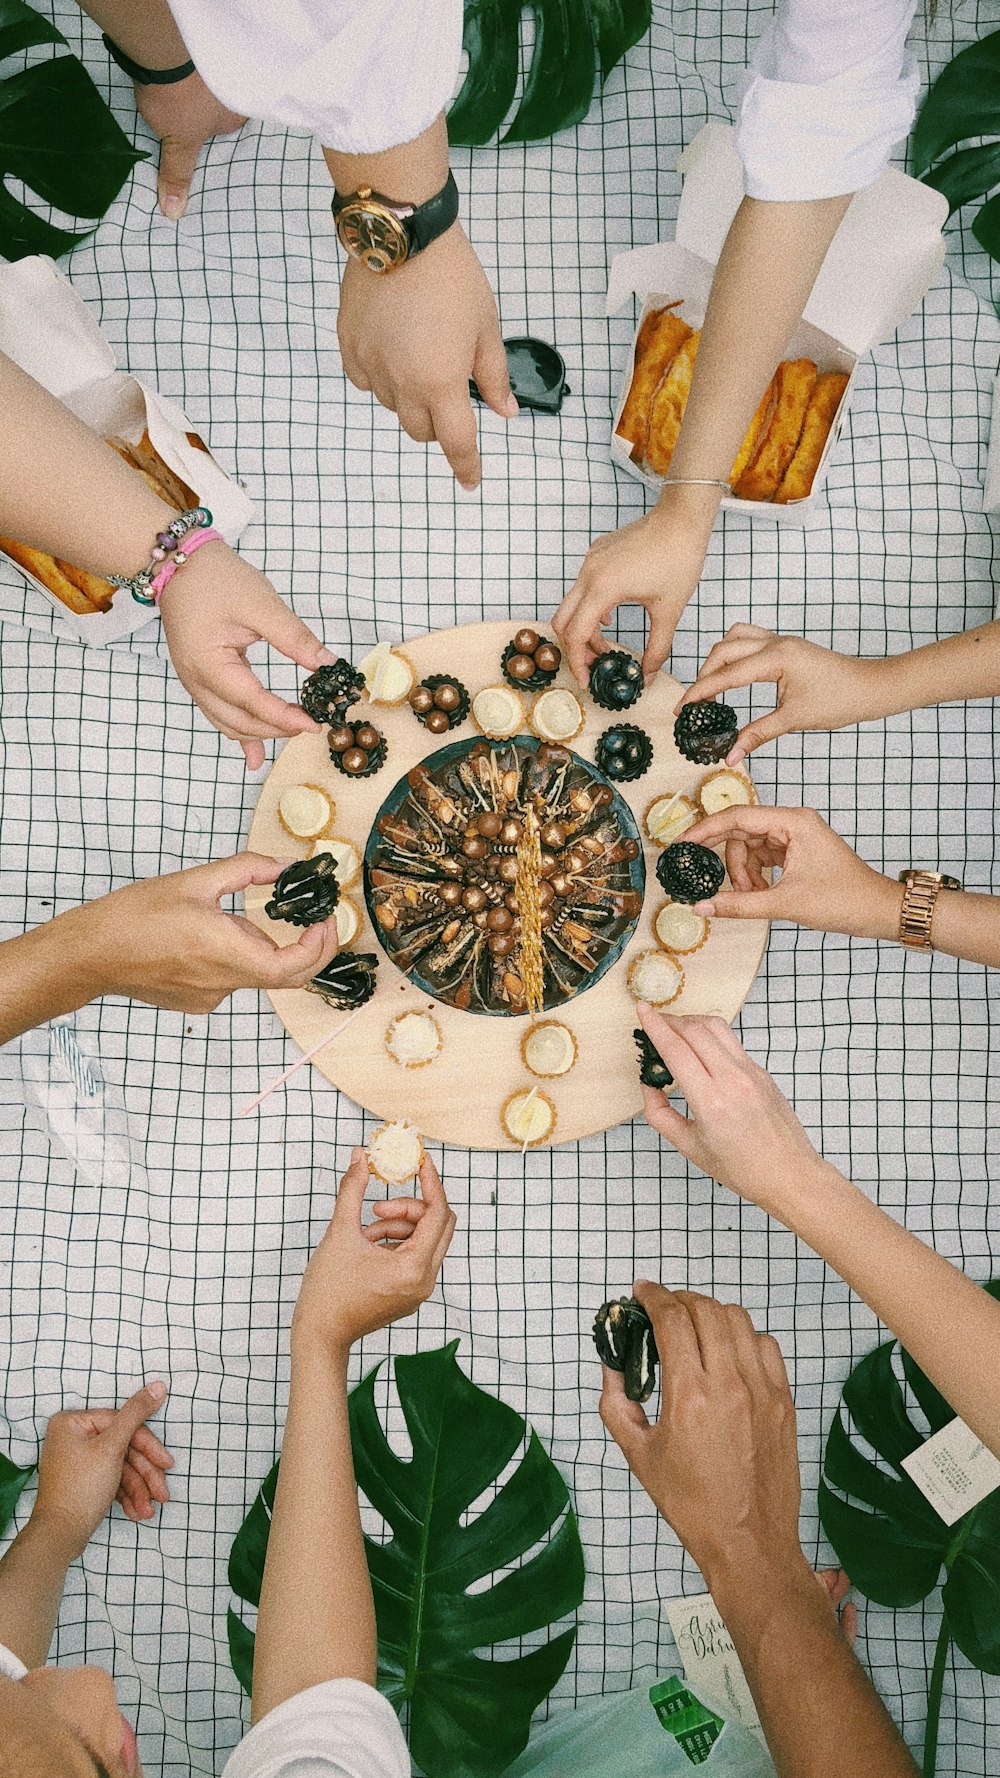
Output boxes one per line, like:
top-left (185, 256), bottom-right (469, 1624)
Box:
top-left (607, 123), bottom-right (948, 521)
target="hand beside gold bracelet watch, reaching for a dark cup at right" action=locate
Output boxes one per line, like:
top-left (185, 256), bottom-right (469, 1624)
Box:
top-left (683, 805), bottom-right (902, 939)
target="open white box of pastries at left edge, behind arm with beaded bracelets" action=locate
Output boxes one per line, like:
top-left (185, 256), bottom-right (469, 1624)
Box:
top-left (0, 254), bottom-right (253, 642)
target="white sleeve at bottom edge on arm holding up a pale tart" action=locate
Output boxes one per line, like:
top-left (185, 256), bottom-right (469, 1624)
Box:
top-left (222, 1678), bottom-right (409, 1778)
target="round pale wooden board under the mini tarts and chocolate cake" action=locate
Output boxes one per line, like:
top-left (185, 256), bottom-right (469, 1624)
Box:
top-left (246, 621), bottom-right (767, 1152)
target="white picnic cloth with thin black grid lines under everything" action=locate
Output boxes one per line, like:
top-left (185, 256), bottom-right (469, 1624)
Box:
top-left (0, 0), bottom-right (1000, 1778)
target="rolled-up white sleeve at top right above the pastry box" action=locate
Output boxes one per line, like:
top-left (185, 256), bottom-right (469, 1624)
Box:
top-left (737, 0), bottom-right (920, 203)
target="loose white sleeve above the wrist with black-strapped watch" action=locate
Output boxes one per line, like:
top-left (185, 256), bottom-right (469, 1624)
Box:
top-left (171, 0), bottom-right (463, 154)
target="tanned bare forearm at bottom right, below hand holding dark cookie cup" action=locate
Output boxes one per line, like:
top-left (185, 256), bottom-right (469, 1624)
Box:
top-left (712, 1563), bottom-right (916, 1778)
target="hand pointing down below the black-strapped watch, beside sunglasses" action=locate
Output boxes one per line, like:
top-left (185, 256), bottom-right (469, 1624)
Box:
top-left (336, 222), bottom-right (518, 489)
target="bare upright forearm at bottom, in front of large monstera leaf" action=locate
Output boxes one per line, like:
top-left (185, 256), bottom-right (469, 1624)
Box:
top-left (251, 1339), bottom-right (375, 1723)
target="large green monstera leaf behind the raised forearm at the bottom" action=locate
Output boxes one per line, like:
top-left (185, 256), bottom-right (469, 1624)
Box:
top-left (230, 1341), bottom-right (584, 1778)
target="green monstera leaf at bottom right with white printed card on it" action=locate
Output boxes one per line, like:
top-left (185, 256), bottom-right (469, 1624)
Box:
top-left (819, 1278), bottom-right (1000, 1778)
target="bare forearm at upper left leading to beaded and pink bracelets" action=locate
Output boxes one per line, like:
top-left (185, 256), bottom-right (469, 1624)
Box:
top-left (0, 354), bottom-right (169, 574)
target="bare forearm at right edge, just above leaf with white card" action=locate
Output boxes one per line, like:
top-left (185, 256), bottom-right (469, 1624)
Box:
top-left (776, 1161), bottom-right (1000, 1456)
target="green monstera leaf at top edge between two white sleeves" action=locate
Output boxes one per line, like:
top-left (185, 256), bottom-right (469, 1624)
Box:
top-left (448, 0), bottom-right (651, 144)
